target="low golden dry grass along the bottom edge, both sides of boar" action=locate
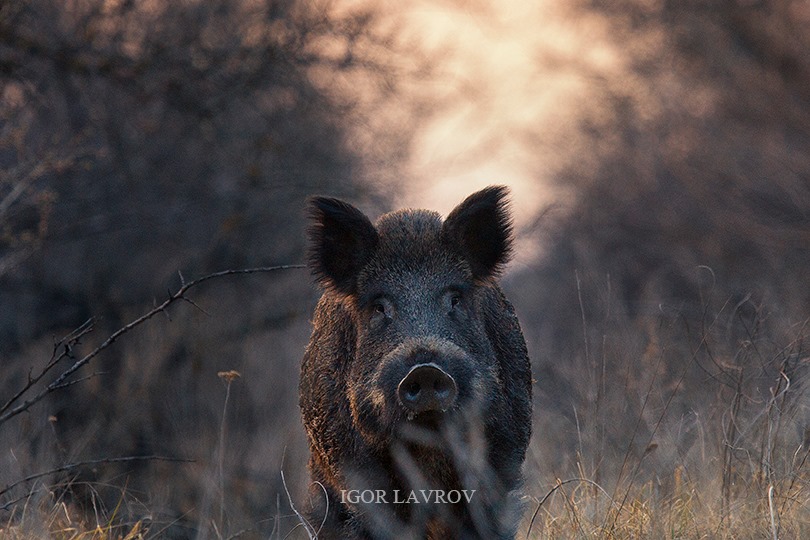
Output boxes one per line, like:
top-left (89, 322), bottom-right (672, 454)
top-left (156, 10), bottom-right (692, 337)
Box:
top-left (0, 438), bottom-right (810, 540)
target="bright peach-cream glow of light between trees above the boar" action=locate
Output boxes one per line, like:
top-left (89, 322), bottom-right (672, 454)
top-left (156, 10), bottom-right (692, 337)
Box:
top-left (356, 0), bottom-right (620, 226)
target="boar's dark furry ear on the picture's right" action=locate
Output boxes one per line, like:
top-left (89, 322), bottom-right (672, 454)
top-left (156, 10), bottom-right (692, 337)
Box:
top-left (442, 186), bottom-right (512, 280)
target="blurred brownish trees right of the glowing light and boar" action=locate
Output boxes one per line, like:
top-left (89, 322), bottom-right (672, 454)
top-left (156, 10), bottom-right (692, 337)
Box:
top-left (520, 0), bottom-right (810, 490)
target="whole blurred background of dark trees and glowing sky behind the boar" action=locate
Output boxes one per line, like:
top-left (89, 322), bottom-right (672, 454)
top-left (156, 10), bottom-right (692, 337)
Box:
top-left (0, 0), bottom-right (810, 538)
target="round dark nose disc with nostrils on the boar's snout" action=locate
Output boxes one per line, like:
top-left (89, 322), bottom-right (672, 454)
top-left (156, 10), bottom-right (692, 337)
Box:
top-left (397, 362), bottom-right (458, 413)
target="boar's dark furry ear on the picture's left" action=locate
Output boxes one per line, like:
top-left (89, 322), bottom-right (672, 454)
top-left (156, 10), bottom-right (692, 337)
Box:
top-left (308, 197), bottom-right (377, 294)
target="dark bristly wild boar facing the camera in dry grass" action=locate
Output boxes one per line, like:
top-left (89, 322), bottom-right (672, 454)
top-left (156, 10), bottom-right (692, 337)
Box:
top-left (300, 187), bottom-right (531, 539)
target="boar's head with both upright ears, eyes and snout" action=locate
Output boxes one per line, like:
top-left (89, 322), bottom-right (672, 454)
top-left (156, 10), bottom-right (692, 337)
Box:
top-left (310, 187), bottom-right (512, 447)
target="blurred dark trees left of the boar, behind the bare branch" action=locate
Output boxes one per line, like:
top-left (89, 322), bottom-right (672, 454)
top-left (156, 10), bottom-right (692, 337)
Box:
top-left (0, 0), bottom-right (416, 532)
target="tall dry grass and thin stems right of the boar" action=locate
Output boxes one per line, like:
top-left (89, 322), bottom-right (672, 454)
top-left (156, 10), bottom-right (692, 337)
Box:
top-left (519, 284), bottom-right (810, 540)
